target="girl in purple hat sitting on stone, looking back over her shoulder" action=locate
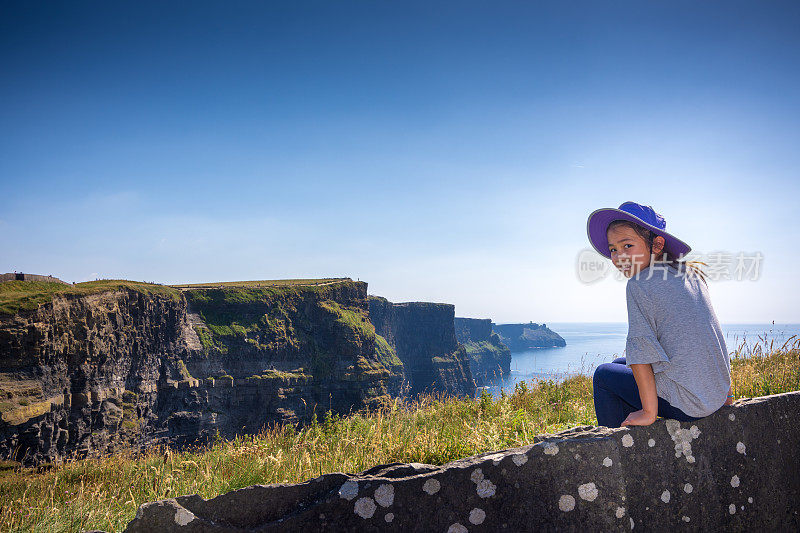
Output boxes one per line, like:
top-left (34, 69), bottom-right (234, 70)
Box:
top-left (587, 202), bottom-right (733, 427)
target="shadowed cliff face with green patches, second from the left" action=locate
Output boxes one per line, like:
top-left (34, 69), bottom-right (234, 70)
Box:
top-left (171, 281), bottom-right (403, 444)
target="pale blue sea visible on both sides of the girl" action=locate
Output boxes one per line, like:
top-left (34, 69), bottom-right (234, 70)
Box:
top-left (486, 322), bottom-right (800, 397)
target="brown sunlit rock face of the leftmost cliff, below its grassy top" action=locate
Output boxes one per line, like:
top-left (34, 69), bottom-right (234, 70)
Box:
top-left (0, 288), bottom-right (185, 464)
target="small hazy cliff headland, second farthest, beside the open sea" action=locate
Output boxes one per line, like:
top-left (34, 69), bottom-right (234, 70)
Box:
top-left (454, 317), bottom-right (511, 386)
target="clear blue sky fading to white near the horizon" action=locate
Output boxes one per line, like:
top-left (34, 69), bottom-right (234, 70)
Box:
top-left (0, 0), bottom-right (800, 323)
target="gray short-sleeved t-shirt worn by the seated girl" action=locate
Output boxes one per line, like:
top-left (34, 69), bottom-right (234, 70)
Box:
top-left (625, 263), bottom-right (731, 417)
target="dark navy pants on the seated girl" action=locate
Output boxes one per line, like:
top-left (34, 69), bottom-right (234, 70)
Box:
top-left (592, 357), bottom-right (700, 428)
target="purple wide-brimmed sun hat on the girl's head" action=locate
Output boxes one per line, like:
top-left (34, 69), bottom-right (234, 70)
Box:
top-left (586, 202), bottom-right (692, 259)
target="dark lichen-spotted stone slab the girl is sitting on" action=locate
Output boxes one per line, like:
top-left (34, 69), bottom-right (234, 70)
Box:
top-left (126, 392), bottom-right (800, 533)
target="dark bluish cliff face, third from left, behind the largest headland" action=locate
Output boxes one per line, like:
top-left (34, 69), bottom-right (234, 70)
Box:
top-left (369, 296), bottom-right (475, 397)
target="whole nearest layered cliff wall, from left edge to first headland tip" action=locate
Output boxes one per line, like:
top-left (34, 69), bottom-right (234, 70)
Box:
top-left (0, 281), bottom-right (403, 464)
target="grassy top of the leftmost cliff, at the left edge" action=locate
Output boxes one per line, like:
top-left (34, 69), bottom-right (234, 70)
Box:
top-left (0, 279), bottom-right (180, 315)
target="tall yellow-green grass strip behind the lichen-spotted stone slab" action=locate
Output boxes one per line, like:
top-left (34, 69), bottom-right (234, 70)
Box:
top-left (0, 337), bottom-right (800, 531)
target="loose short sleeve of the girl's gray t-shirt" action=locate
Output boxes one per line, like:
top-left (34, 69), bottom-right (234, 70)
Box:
top-left (625, 283), bottom-right (670, 373)
